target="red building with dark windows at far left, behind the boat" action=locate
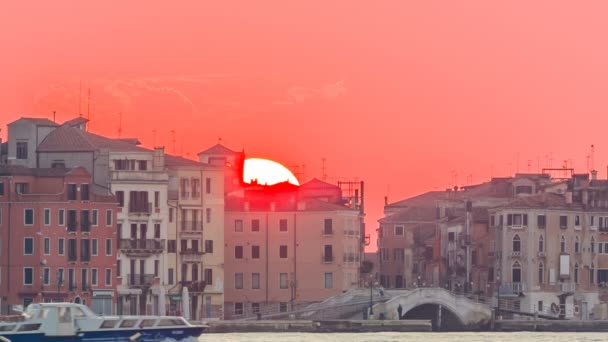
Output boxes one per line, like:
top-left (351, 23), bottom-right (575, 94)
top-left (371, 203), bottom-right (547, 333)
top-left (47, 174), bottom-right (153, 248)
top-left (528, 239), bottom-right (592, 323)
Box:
top-left (0, 165), bottom-right (118, 314)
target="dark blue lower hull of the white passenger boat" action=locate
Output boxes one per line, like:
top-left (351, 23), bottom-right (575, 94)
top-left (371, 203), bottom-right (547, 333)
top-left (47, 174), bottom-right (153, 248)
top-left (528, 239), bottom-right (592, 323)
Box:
top-left (0, 327), bottom-right (205, 342)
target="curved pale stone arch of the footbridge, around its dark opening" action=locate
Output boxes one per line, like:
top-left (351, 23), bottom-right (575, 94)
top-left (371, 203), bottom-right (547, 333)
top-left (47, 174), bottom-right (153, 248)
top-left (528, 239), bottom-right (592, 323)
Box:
top-left (374, 288), bottom-right (492, 329)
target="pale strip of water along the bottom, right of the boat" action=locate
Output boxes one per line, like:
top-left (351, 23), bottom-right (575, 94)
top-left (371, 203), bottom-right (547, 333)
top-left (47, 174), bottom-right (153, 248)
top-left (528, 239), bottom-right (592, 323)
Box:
top-left (198, 332), bottom-right (608, 342)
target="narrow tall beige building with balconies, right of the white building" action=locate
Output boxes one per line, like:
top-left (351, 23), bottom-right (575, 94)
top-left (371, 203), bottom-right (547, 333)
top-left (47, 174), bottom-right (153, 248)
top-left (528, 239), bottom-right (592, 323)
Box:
top-left (165, 155), bottom-right (225, 320)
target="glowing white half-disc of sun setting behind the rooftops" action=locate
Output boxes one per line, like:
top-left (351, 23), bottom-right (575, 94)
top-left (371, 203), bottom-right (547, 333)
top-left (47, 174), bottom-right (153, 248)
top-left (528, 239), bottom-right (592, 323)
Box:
top-left (243, 158), bottom-right (300, 185)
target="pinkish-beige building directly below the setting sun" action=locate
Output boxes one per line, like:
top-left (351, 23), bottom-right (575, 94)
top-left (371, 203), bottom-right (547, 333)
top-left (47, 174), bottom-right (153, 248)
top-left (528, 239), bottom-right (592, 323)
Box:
top-left (224, 180), bottom-right (363, 318)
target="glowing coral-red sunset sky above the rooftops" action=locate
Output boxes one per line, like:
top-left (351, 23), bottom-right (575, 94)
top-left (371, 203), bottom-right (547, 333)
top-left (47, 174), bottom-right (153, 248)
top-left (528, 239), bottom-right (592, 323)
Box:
top-left (0, 0), bottom-right (608, 250)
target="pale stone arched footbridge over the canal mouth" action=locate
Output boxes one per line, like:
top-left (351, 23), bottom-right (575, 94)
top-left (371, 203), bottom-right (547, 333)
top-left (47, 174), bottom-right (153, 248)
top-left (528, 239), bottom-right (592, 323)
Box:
top-left (373, 288), bottom-right (492, 330)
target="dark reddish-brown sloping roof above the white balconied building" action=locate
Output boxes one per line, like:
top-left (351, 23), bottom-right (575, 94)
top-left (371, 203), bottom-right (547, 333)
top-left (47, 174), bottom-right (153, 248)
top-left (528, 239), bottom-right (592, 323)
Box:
top-left (37, 125), bottom-right (150, 152)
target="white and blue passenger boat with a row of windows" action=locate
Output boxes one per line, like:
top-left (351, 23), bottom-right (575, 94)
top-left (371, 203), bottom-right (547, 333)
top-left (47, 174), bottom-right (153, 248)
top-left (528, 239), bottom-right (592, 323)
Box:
top-left (0, 303), bottom-right (207, 342)
